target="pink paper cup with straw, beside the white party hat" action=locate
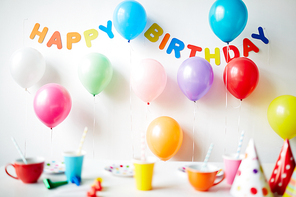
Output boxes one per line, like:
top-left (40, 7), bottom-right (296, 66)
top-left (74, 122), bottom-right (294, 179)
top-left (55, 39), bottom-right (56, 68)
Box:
top-left (222, 153), bottom-right (244, 185)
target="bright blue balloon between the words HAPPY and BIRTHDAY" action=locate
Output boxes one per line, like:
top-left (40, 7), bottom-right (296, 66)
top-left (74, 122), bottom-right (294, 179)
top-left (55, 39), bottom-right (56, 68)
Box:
top-left (113, 1), bottom-right (147, 41)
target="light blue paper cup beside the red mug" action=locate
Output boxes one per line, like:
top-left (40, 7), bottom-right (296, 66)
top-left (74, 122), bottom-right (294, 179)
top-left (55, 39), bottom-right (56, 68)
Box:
top-left (63, 151), bottom-right (86, 183)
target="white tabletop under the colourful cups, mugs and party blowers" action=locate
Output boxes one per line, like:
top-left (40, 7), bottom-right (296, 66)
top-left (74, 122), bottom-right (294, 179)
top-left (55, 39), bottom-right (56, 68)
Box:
top-left (0, 160), bottom-right (274, 197)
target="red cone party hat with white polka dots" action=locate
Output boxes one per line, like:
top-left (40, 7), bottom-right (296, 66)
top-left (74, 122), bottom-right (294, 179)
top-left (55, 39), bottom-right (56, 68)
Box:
top-left (269, 139), bottom-right (296, 195)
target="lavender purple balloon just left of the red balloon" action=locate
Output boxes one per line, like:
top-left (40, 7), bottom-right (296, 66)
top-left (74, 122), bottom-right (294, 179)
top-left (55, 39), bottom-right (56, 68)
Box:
top-left (177, 57), bottom-right (214, 101)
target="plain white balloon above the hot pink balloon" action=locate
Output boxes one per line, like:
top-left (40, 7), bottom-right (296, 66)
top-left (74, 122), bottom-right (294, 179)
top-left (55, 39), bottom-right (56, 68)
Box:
top-left (10, 47), bottom-right (45, 88)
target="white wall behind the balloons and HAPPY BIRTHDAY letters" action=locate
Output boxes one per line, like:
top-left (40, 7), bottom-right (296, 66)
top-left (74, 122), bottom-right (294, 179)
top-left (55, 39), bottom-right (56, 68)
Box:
top-left (0, 0), bottom-right (296, 165)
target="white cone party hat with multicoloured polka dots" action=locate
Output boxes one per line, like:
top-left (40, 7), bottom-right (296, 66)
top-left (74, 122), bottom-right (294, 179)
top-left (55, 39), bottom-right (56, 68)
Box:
top-left (230, 139), bottom-right (273, 197)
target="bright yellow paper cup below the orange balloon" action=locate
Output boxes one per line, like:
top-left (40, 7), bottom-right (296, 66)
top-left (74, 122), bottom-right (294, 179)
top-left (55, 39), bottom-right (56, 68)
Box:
top-left (133, 159), bottom-right (155, 191)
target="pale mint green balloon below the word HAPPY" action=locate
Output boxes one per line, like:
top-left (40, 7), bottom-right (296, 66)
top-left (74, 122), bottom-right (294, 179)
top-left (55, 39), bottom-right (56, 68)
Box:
top-left (78, 53), bottom-right (113, 96)
